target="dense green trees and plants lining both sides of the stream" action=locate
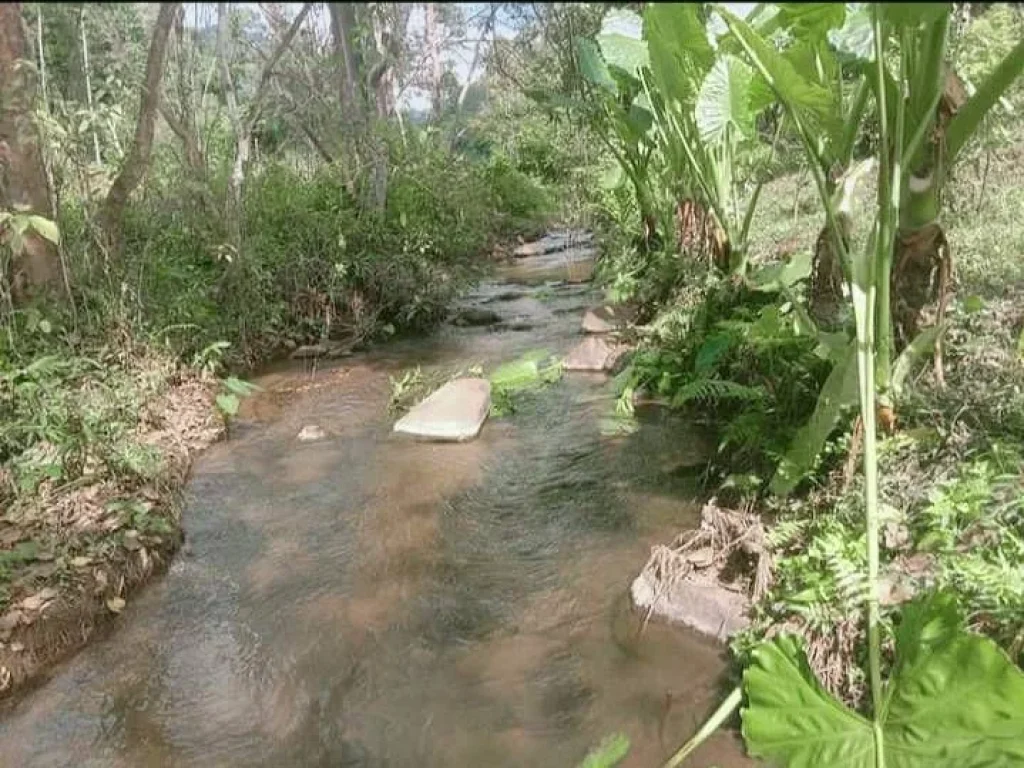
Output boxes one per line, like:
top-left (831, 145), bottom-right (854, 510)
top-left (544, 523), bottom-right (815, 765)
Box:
top-left (0, 3), bottom-right (1024, 766)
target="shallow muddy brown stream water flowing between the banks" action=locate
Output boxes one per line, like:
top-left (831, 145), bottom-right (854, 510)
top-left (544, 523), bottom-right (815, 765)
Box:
top-left (0, 253), bottom-right (750, 768)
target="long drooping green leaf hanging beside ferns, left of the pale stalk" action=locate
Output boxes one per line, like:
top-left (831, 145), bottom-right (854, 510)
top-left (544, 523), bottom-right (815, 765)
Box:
top-left (768, 340), bottom-right (858, 496)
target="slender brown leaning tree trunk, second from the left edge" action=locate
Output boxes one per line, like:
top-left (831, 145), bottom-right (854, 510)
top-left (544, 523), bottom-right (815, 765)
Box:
top-left (102, 3), bottom-right (181, 256)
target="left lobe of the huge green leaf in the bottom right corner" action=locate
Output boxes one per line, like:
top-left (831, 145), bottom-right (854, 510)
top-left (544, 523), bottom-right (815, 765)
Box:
top-left (741, 636), bottom-right (874, 768)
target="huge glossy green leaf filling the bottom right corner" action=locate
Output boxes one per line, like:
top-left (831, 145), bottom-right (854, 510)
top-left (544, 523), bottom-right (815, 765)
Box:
top-left (742, 594), bottom-right (1024, 768)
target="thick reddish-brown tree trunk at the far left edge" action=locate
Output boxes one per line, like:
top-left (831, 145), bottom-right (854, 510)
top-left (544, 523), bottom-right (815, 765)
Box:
top-left (0, 3), bottom-right (60, 300)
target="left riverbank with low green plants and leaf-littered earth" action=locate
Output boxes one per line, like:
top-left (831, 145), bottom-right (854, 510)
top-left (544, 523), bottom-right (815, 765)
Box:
top-left (0, 352), bottom-right (224, 701)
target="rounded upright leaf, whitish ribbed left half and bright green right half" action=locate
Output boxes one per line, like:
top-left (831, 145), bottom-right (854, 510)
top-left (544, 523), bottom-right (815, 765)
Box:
top-left (694, 55), bottom-right (755, 143)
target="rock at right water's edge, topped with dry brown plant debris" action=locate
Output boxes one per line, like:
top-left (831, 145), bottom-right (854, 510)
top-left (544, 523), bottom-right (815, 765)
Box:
top-left (630, 569), bottom-right (750, 640)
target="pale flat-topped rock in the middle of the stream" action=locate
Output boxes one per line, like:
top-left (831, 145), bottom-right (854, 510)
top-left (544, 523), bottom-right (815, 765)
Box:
top-left (394, 379), bottom-right (490, 442)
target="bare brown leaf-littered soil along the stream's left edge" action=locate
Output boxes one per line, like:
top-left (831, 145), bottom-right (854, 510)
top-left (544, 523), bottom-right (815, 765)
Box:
top-left (0, 372), bottom-right (224, 709)
